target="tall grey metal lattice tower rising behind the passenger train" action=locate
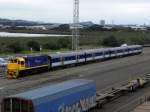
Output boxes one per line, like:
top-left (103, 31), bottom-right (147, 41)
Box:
top-left (72, 0), bottom-right (80, 50)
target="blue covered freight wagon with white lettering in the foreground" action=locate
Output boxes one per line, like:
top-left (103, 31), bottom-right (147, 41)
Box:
top-left (2, 79), bottom-right (96, 112)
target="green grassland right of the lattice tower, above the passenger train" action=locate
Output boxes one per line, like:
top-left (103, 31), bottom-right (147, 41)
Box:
top-left (80, 31), bottom-right (150, 45)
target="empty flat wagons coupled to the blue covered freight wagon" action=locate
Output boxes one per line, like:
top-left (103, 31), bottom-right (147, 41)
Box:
top-left (2, 74), bottom-right (150, 112)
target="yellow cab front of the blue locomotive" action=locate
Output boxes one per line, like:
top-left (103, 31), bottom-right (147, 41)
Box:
top-left (7, 57), bottom-right (25, 79)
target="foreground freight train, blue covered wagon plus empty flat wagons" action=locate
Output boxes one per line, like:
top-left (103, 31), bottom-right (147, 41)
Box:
top-left (1, 75), bottom-right (150, 112)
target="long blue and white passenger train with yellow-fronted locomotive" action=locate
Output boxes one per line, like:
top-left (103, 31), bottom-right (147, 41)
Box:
top-left (7, 45), bottom-right (143, 79)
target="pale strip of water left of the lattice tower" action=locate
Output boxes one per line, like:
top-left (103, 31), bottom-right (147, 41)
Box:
top-left (0, 32), bottom-right (71, 37)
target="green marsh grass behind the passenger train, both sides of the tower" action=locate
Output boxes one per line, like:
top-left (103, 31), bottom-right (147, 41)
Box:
top-left (0, 31), bottom-right (150, 55)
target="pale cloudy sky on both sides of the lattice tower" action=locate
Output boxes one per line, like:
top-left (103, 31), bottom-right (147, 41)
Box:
top-left (0, 0), bottom-right (150, 24)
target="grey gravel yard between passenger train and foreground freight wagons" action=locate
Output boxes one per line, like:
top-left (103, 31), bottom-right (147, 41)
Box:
top-left (0, 48), bottom-right (150, 112)
